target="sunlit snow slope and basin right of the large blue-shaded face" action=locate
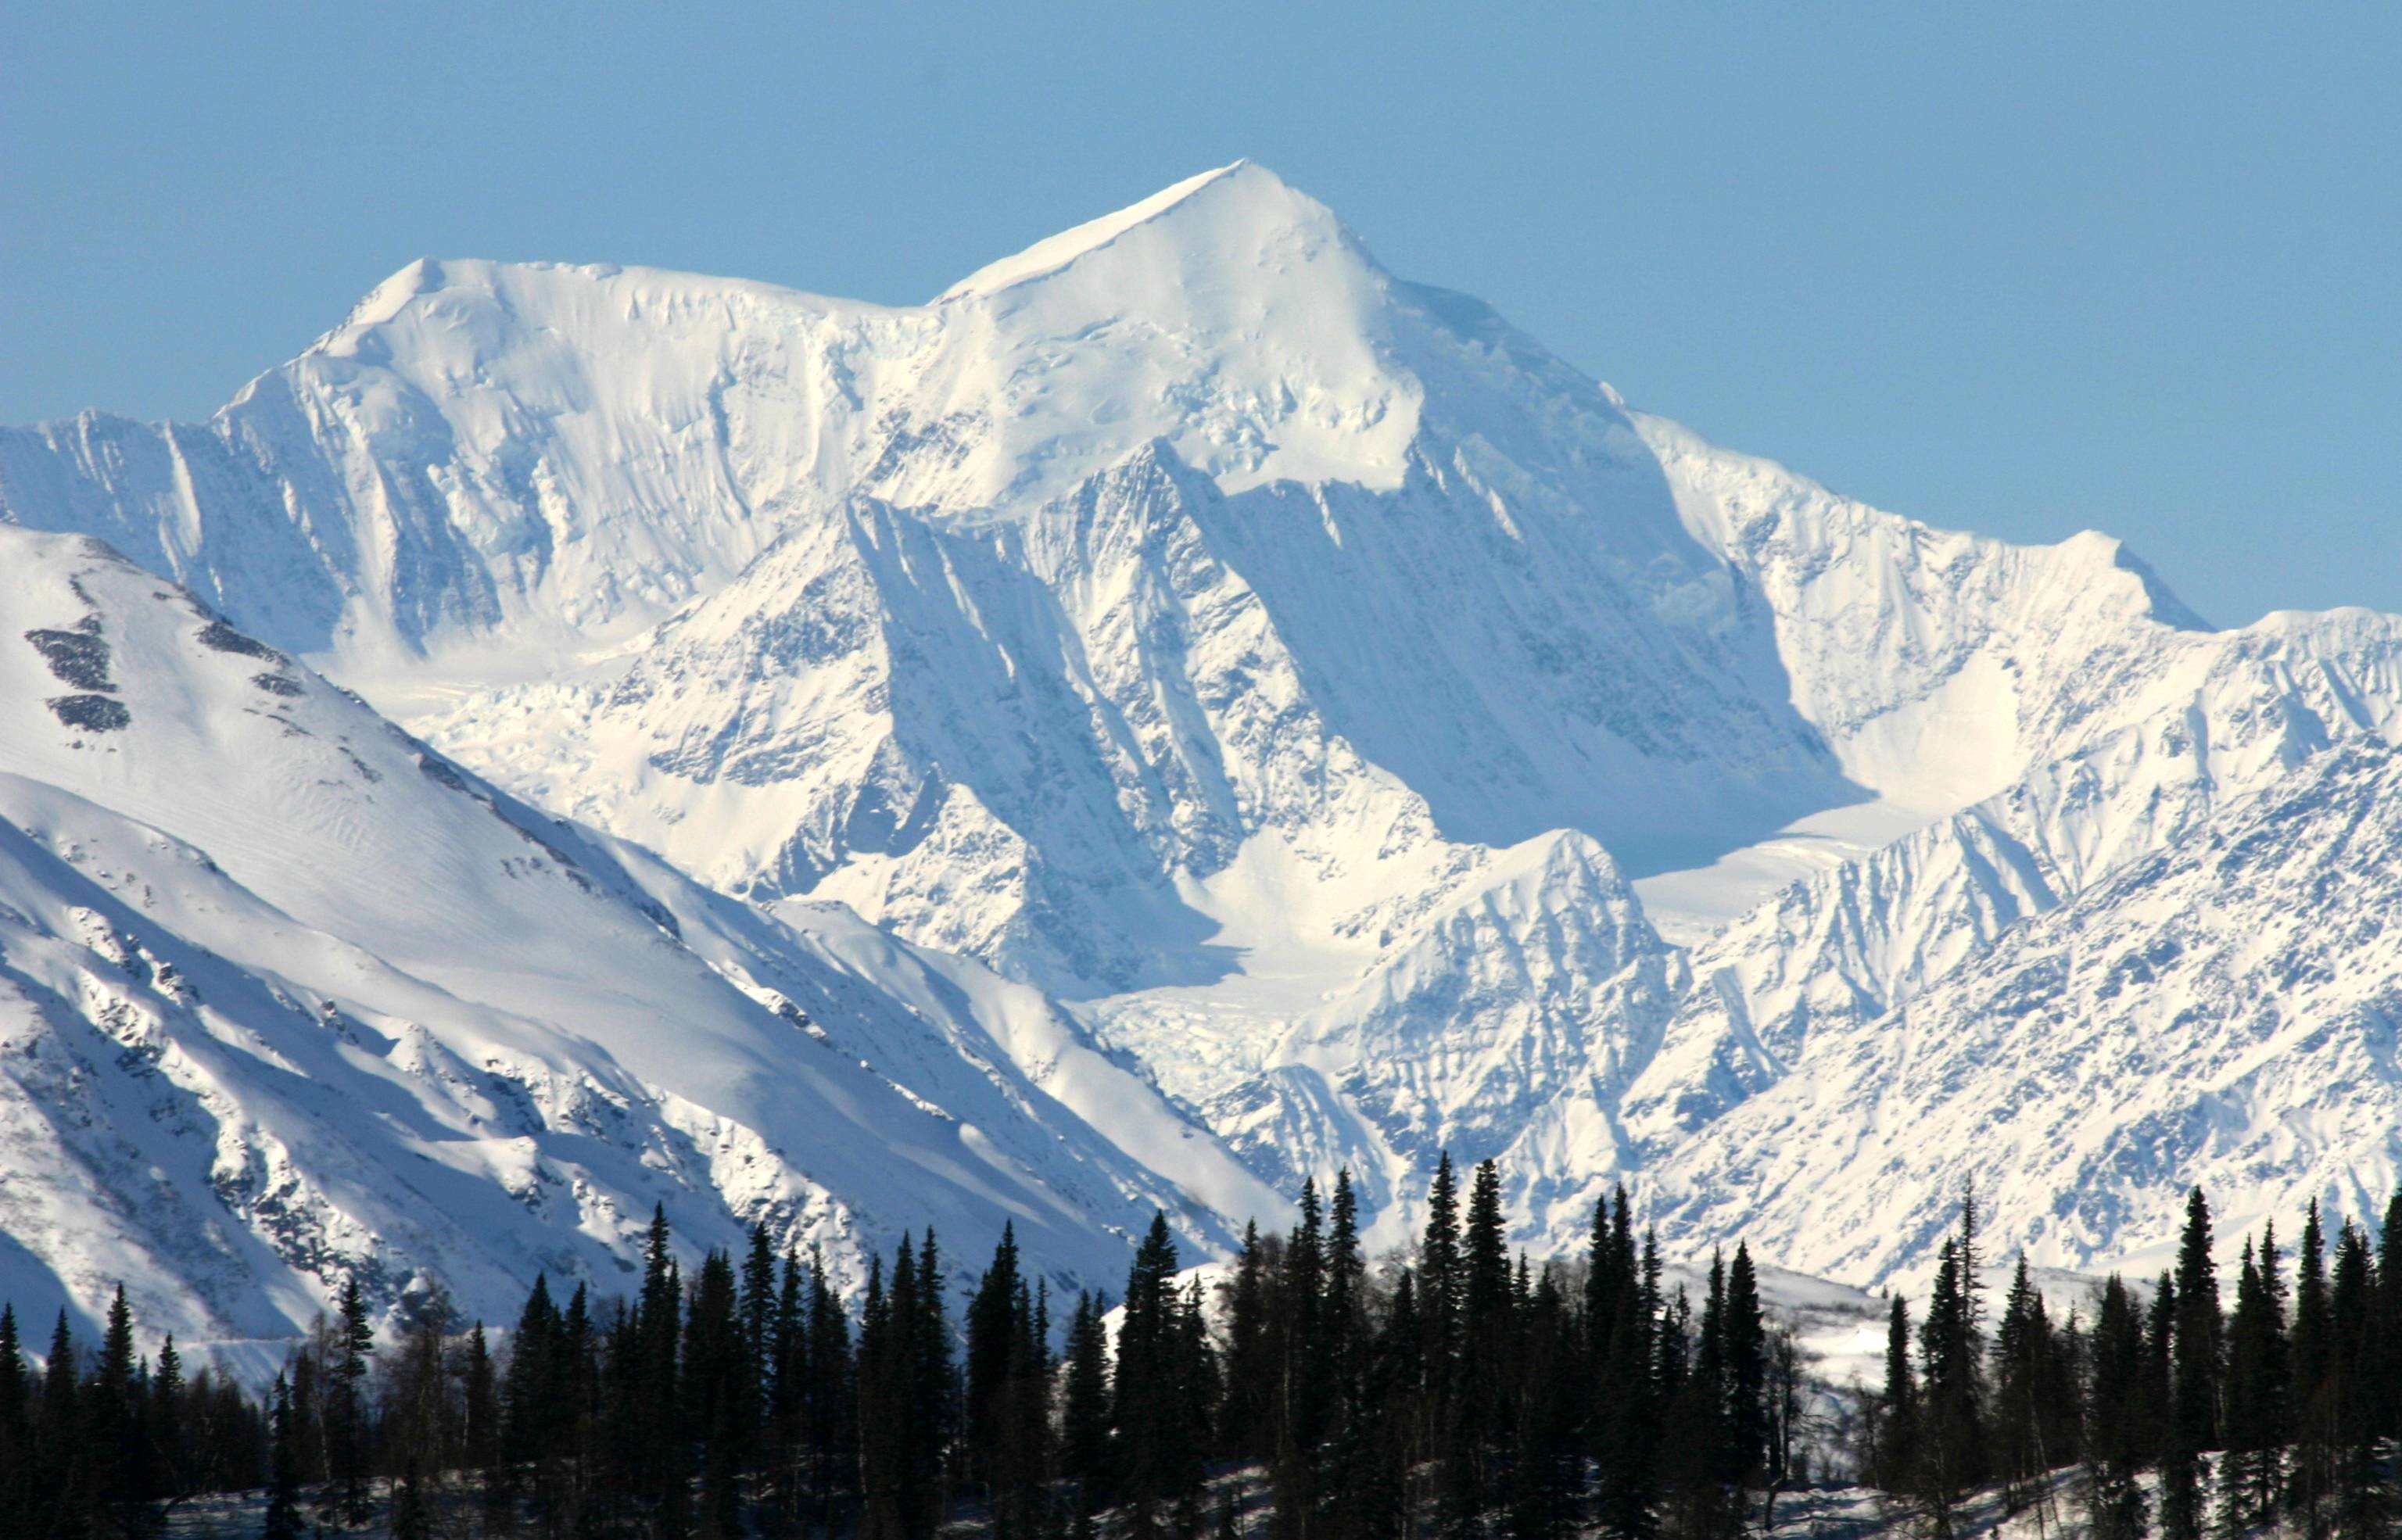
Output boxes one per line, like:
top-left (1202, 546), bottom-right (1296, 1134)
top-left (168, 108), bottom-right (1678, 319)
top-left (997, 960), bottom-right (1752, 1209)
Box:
top-left (1633, 414), bottom-right (2207, 940)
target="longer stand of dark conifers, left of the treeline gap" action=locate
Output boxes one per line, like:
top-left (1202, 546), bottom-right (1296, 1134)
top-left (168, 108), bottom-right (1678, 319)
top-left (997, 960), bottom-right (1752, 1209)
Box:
top-left (0, 1155), bottom-right (1799, 1540)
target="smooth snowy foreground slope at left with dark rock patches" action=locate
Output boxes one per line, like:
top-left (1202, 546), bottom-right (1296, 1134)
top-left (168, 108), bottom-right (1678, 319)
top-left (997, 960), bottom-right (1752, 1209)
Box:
top-left (0, 528), bottom-right (1275, 1338)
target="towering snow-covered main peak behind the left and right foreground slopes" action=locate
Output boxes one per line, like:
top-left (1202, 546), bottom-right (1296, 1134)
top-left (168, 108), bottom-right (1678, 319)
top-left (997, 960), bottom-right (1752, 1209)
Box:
top-left (0, 152), bottom-right (2402, 1283)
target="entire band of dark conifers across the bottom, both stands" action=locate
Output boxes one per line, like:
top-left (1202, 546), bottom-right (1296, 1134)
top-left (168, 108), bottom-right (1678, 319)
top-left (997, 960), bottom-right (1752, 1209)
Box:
top-left (0, 1172), bottom-right (2402, 1540)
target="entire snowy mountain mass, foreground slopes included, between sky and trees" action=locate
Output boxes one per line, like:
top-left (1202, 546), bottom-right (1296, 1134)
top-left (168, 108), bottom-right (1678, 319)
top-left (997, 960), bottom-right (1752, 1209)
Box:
top-left (0, 163), bottom-right (2402, 1341)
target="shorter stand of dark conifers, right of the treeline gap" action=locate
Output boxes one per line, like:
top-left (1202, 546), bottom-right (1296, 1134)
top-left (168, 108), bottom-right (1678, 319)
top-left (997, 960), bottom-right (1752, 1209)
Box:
top-left (1859, 1189), bottom-right (2402, 1540)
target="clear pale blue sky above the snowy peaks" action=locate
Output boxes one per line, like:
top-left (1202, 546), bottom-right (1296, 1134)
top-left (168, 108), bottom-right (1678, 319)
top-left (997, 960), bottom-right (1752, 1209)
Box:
top-left (0, 0), bottom-right (2402, 622)
